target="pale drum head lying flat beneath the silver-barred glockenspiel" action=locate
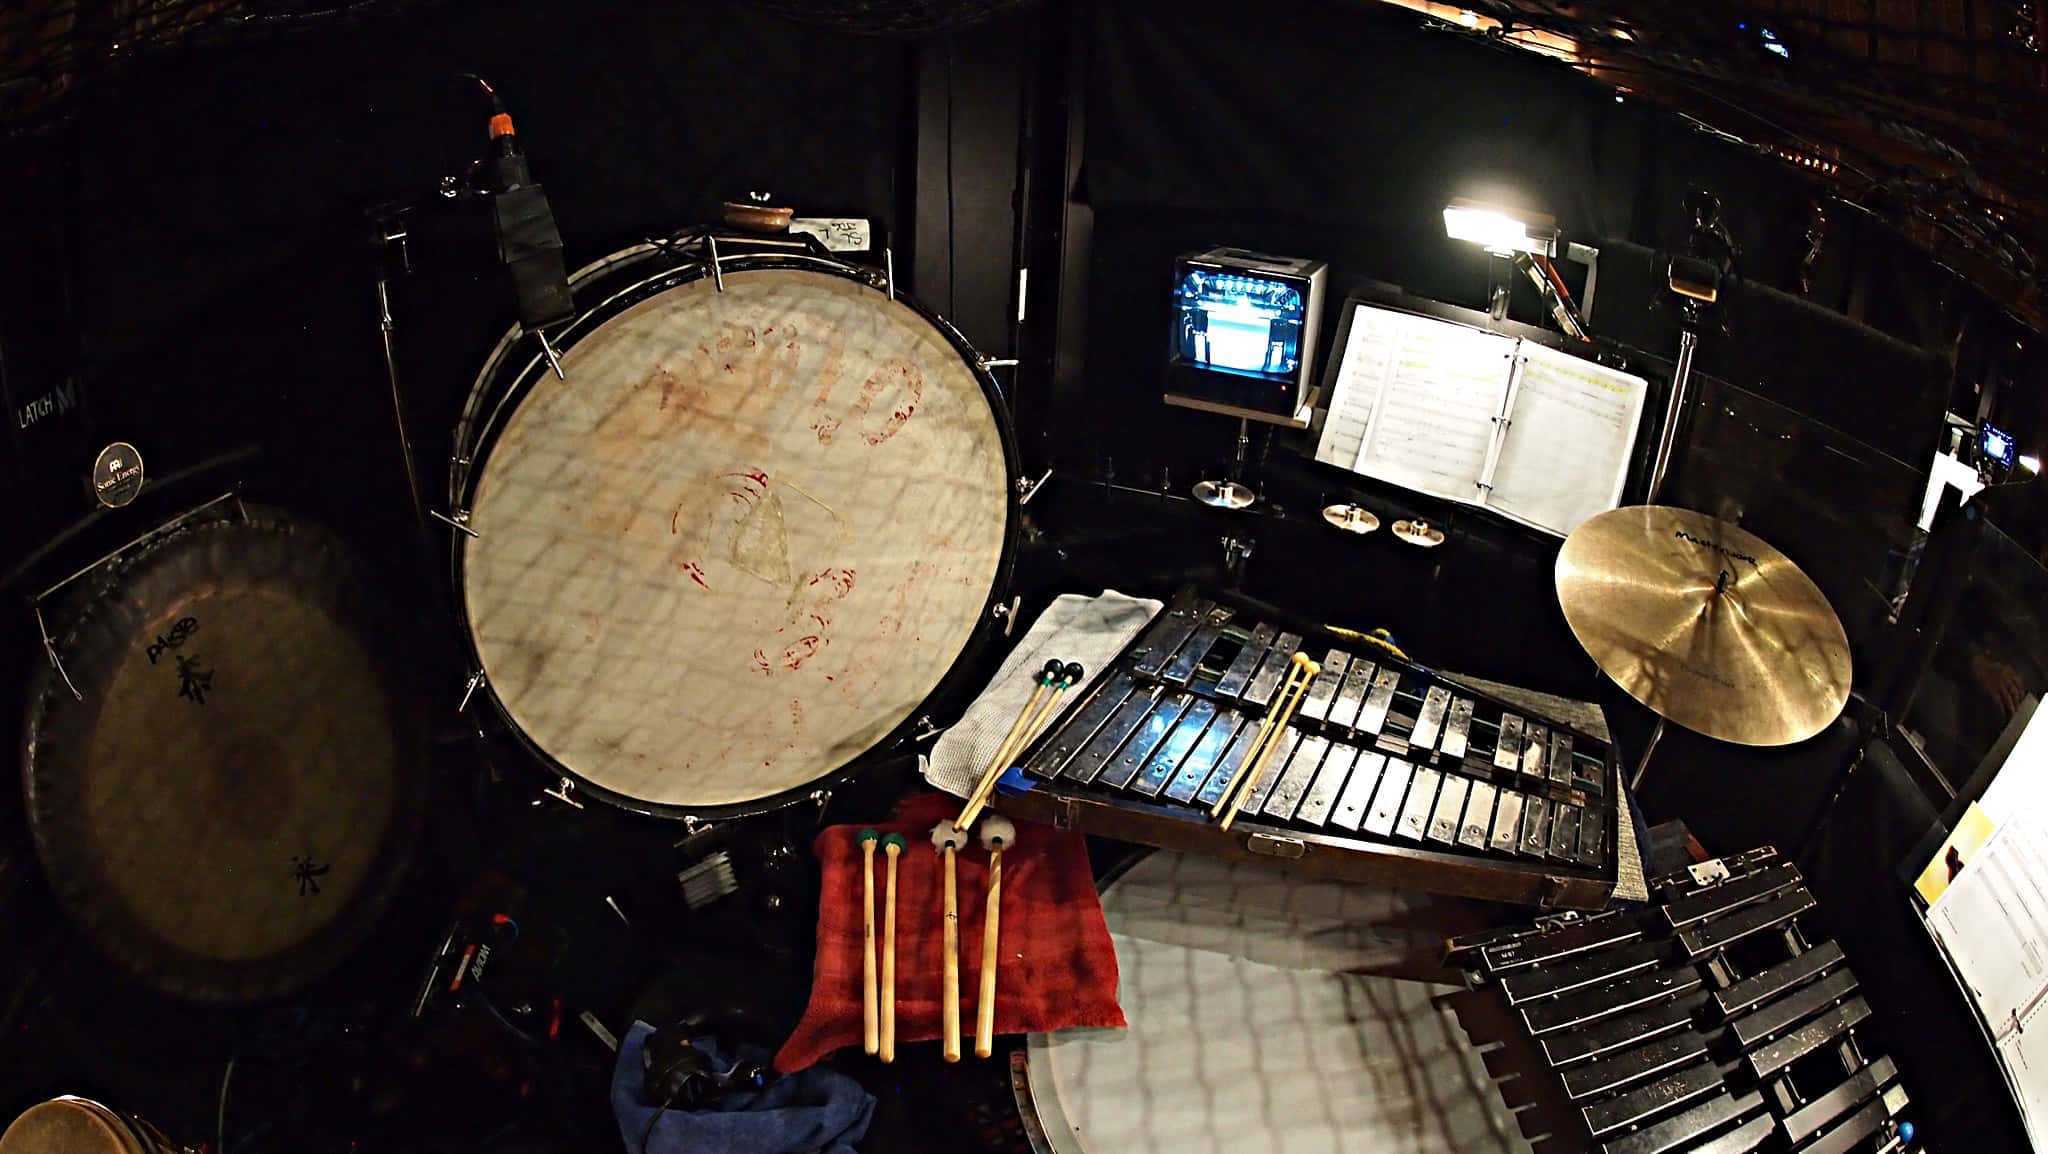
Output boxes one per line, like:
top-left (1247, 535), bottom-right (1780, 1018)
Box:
top-left (1030, 853), bottom-right (1530, 1154)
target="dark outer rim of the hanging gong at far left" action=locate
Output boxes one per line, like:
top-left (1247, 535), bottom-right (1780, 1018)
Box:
top-left (18, 500), bottom-right (428, 1004)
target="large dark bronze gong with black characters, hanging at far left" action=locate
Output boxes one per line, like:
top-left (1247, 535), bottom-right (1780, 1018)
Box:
top-left (23, 500), bottom-right (426, 1002)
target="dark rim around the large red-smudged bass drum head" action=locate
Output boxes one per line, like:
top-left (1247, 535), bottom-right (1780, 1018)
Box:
top-left (449, 238), bottom-right (1022, 822)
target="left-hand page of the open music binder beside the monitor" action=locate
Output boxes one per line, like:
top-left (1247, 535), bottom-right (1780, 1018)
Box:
top-left (1354, 314), bottom-right (1516, 502)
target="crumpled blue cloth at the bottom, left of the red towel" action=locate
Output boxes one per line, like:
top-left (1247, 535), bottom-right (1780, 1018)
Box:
top-left (612, 1021), bottom-right (874, 1154)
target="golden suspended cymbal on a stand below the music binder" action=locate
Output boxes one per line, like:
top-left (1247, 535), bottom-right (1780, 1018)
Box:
top-left (1556, 504), bottom-right (1849, 746)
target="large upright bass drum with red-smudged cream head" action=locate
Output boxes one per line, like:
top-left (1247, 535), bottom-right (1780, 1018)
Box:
top-left (451, 244), bottom-right (1018, 818)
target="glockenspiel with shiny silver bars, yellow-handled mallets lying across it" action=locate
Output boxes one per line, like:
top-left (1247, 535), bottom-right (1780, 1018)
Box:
top-left (1001, 590), bottom-right (1618, 908)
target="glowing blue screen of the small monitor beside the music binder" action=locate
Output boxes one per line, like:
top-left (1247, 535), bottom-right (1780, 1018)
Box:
top-left (1174, 266), bottom-right (1307, 381)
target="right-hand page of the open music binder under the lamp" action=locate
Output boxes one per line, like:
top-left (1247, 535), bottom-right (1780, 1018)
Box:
top-left (1485, 340), bottom-right (1647, 535)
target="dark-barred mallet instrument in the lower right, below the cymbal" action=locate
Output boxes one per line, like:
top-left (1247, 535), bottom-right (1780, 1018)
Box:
top-left (1450, 849), bottom-right (1911, 1154)
